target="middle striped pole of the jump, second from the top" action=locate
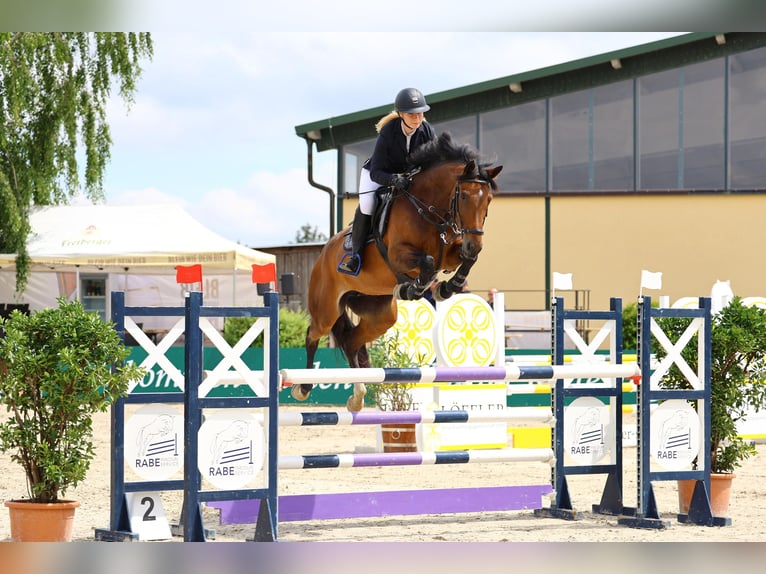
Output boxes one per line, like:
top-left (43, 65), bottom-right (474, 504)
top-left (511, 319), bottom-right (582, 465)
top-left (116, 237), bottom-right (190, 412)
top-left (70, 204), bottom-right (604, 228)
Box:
top-left (279, 407), bottom-right (556, 427)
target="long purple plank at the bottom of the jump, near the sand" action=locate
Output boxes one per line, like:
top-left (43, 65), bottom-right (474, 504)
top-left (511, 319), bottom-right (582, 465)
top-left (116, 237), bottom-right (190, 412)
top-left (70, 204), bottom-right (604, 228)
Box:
top-left (206, 484), bottom-right (553, 524)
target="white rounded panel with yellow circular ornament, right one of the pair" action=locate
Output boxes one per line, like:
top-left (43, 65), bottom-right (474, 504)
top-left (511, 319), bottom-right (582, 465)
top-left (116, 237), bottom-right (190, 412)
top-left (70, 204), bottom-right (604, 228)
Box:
top-left (434, 293), bottom-right (497, 367)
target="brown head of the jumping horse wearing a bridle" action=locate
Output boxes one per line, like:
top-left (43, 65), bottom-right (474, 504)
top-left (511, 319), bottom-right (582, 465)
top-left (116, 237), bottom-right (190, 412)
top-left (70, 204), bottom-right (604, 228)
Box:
top-left (451, 159), bottom-right (503, 259)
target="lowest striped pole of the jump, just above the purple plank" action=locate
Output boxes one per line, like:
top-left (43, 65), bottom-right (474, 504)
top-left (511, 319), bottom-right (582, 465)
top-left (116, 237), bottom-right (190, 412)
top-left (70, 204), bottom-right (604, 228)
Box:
top-left (279, 448), bottom-right (555, 470)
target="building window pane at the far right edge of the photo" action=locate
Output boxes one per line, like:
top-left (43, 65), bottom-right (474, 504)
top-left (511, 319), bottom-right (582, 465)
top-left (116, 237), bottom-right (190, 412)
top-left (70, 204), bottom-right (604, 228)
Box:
top-left (729, 48), bottom-right (766, 189)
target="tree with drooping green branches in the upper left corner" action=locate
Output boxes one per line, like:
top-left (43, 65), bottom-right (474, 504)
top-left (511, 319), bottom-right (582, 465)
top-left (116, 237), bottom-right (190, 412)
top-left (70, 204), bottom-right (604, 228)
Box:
top-left (0, 32), bottom-right (153, 293)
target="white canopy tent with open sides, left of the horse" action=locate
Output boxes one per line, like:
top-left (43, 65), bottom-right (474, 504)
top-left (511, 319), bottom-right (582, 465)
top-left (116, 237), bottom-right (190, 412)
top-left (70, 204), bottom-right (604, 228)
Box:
top-left (0, 204), bottom-right (276, 324)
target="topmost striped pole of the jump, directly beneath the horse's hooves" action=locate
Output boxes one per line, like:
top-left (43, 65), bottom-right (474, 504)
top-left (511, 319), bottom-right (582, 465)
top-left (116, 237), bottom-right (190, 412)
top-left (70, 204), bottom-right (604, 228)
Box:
top-left (280, 363), bottom-right (641, 387)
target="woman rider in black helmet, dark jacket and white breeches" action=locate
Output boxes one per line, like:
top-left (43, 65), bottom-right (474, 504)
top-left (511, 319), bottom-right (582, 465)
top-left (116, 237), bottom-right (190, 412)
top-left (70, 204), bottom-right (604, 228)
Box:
top-left (338, 88), bottom-right (436, 275)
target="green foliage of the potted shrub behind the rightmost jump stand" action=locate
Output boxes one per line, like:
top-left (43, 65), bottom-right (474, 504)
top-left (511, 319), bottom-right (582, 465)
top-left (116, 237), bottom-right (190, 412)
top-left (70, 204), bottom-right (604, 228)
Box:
top-left (652, 297), bottom-right (766, 472)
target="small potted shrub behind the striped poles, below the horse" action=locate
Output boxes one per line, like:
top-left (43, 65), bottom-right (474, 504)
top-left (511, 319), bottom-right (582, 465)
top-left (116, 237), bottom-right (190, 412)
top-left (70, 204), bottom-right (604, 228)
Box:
top-left (367, 332), bottom-right (419, 452)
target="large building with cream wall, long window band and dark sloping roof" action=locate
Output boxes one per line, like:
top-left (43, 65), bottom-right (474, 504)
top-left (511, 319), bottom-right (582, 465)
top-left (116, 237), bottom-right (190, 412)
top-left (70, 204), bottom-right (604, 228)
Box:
top-left (295, 33), bottom-right (766, 309)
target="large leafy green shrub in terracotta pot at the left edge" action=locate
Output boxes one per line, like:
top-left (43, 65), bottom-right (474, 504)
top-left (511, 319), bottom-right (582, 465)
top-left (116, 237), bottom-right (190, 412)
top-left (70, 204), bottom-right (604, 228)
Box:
top-left (0, 298), bottom-right (144, 540)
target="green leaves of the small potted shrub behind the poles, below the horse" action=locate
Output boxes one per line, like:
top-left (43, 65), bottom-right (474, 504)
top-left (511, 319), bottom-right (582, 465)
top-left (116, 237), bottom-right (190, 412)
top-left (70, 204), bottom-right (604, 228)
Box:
top-left (367, 333), bottom-right (424, 411)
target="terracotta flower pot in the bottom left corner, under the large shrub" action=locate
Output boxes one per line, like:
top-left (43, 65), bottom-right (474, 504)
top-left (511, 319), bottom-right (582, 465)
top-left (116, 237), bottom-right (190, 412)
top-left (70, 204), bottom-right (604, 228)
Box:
top-left (5, 500), bottom-right (80, 542)
